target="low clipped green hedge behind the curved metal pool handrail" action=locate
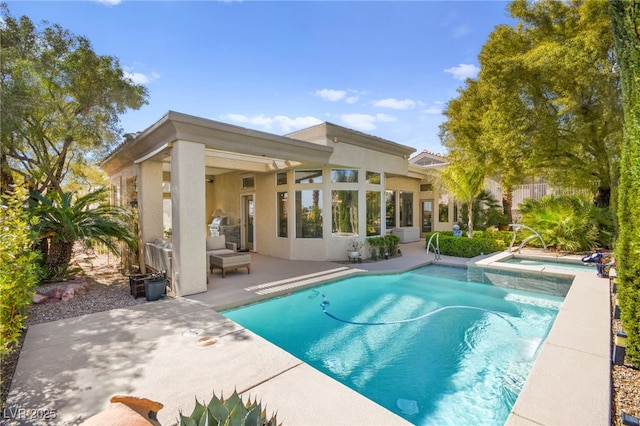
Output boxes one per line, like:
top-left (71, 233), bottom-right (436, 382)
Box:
top-left (425, 231), bottom-right (504, 258)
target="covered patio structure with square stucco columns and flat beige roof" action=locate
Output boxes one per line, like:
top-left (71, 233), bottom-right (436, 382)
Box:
top-left (102, 111), bottom-right (333, 296)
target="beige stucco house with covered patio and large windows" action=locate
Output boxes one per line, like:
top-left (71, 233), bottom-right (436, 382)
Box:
top-left (101, 111), bottom-right (453, 295)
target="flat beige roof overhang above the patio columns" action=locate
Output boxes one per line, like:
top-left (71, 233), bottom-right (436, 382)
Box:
top-left (101, 111), bottom-right (333, 175)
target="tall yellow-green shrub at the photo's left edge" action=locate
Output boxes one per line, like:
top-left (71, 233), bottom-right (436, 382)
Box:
top-left (0, 189), bottom-right (39, 356)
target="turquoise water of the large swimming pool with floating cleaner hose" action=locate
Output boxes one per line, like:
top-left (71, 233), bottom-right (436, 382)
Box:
top-left (223, 265), bottom-right (563, 425)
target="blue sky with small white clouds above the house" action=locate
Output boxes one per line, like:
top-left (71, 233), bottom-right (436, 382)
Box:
top-left (8, 0), bottom-right (513, 153)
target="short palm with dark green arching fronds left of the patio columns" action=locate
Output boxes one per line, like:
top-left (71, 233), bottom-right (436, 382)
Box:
top-left (32, 188), bottom-right (136, 278)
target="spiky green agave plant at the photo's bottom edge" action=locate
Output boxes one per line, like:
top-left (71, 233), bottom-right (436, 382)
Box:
top-left (180, 391), bottom-right (278, 426)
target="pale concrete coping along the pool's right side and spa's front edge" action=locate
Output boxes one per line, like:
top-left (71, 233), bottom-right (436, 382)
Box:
top-left (474, 252), bottom-right (611, 425)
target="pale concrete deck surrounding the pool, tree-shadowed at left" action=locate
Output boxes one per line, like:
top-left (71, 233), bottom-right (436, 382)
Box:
top-left (3, 240), bottom-right (611, 425)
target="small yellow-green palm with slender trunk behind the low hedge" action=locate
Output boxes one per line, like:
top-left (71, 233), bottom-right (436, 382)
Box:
top-left (440, 163), bottom-right (484, 238)
